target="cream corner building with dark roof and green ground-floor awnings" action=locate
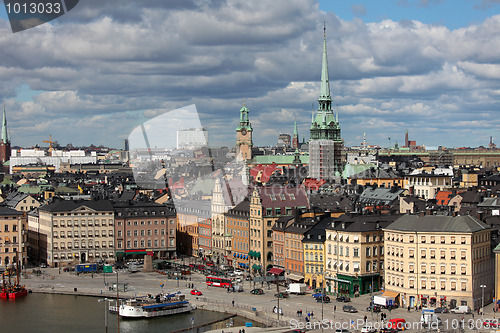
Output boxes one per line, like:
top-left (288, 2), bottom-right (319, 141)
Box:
top-left (325, 214), bottom-right (400, 295)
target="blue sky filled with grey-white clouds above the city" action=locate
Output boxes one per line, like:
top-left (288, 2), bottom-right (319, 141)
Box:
top-left (0, 0), bottom-right (500, 147)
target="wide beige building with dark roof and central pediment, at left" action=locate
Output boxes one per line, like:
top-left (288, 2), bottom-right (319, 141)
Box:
top-left (28, 200), bottom-right (115, 267)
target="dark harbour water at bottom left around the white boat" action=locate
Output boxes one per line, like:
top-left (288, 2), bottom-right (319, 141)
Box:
top-left (0, 294), bottom-right (262, 333)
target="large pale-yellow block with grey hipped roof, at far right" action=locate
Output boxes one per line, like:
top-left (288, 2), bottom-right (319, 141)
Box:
top-left (384, 215), bottom-right (494, 309)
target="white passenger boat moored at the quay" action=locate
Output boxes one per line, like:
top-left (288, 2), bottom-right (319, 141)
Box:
top-left (109, 294), bottom-right (196, 318)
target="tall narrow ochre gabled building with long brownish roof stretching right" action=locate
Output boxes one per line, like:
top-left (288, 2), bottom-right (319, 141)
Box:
top-left (249, 186), bottom-right (309, 269)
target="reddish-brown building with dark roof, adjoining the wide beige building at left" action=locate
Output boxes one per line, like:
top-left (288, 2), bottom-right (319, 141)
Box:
top-left (113, 201), bottom-right (176, 259)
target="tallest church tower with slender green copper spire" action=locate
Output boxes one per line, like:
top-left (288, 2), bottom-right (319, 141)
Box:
top-left (309, 26), bottom-right (344, 180)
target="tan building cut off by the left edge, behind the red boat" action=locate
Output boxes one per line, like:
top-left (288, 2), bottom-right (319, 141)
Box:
top-left (0, 207), bottom-right (28, 268)
